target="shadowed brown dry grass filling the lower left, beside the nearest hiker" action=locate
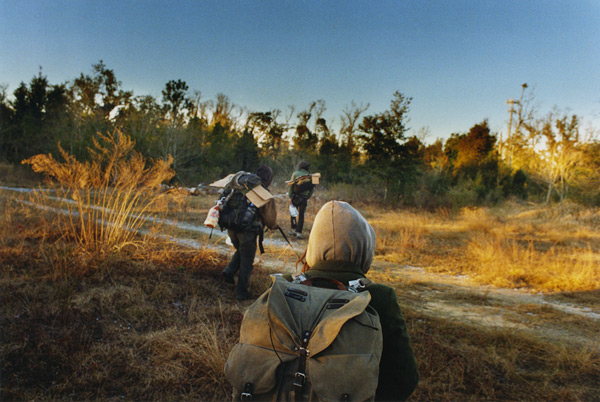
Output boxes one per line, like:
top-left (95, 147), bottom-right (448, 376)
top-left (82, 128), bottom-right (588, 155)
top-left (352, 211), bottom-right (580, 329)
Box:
top-left (0, 199), bottom-right (248, 400)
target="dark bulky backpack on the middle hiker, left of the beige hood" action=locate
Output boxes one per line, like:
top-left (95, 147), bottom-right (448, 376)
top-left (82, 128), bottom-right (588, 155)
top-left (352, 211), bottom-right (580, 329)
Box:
top-left (218, 172), bottom-right (262, 232)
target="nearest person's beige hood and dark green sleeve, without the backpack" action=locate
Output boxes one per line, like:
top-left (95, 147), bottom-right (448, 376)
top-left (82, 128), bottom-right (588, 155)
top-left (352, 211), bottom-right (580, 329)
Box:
top-left (296, 201), bottom-right (419, 401)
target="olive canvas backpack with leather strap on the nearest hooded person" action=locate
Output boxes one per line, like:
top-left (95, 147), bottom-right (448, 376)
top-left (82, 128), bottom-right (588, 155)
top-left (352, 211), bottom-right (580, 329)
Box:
top-left (225, 275), bottom-right (383, 401)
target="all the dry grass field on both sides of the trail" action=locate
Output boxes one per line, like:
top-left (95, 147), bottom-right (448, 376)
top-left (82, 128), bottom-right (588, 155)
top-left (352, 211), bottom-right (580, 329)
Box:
top-left (0, 183), bottom-right (600, 401)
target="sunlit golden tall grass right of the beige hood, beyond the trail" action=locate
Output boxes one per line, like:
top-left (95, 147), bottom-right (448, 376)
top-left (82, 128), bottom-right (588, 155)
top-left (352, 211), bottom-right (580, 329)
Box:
top-left (367, 203), bottom-right (600, 292)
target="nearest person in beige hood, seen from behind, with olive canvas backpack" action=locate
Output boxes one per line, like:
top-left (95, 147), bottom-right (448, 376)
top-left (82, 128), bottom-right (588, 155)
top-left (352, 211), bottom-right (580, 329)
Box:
top-left (225, 201), bottom-right (419, 401)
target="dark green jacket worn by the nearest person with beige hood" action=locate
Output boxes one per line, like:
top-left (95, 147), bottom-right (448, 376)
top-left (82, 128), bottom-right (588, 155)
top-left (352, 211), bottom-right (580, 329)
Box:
top-left (288, 261), bottom-right (419, 401)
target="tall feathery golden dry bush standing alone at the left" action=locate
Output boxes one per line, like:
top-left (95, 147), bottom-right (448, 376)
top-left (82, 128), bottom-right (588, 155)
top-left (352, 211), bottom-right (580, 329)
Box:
top-left (23, 131), bottom-right (182, 252)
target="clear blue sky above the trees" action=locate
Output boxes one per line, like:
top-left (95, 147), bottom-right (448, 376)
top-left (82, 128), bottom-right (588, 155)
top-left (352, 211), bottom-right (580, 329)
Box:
top-left (0, 0), bottom-right (600, 142)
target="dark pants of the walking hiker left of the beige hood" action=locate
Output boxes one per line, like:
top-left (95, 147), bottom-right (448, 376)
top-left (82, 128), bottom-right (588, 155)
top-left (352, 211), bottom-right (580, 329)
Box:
top-left (223, 229), bottom-right (258, 300)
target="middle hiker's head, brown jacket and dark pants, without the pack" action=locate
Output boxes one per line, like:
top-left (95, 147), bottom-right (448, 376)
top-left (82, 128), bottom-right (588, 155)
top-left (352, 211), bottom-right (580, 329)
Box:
top-left (219, 165), bottom-right (278, 301)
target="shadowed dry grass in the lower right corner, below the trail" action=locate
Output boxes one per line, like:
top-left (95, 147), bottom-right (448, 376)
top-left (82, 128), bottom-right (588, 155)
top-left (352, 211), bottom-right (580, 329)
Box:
top-left (404, 309), bottom-right (600, 401)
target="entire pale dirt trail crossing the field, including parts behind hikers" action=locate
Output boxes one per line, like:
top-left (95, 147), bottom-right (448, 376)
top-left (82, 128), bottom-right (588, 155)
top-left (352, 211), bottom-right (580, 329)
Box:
top-left (4, 188), bottom-right (600, 349)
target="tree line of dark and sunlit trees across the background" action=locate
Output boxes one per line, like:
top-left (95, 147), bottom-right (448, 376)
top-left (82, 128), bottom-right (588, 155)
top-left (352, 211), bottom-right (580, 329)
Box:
top-left (0, 61), bottom-right (600, 208)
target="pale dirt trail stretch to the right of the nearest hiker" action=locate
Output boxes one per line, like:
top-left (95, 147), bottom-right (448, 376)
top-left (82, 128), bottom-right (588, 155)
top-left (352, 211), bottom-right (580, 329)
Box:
top-left (374, 262), bottom-right (600, 349)
